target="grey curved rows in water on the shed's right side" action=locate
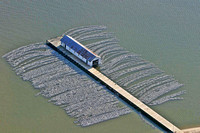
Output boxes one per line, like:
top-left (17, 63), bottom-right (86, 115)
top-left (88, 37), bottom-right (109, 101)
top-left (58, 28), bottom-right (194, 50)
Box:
top-left (72, 26), bottom-right (185, 105)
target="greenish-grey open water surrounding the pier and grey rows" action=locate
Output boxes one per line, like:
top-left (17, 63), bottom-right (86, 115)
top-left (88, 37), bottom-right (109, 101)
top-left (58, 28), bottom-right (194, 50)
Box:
top-left (0, 0), bottom-right (200, 133)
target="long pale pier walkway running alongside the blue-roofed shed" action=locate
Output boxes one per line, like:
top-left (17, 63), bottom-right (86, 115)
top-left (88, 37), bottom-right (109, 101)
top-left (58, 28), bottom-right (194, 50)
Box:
top-left (46, 37), bottom-right (200, 133)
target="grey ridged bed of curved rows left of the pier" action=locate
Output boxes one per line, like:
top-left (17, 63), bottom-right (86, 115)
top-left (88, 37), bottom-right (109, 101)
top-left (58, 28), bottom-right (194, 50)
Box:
top-left (3, 40), bottom-right (131, 126)
